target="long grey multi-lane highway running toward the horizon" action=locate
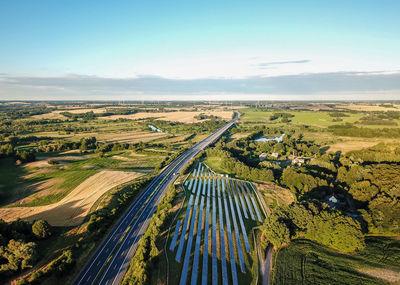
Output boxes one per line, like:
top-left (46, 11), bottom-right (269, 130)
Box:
top-left (73, 113), bottom-right (238, 285)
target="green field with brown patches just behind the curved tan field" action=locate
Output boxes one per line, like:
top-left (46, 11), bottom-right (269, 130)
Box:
top-left (0, 151), bottom-right (167, 206)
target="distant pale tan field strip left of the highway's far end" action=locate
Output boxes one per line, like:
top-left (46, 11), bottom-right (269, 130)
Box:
top-left (101, 110), bottom-right (233, 123)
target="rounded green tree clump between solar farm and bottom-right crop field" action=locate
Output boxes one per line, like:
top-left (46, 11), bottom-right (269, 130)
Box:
top-left (263, 202), bottom-right (365, 252)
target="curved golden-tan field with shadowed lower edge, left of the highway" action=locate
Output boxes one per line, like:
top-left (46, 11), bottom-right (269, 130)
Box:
top-left (0, 170), bottom-right (143, 226)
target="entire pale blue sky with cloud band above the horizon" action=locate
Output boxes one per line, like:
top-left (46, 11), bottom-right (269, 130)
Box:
top-left (0, 0), bottom-right (400, 100)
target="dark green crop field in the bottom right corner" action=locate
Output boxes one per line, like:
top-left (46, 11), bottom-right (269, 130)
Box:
top-left (272, 237), bottom-right (400, 285)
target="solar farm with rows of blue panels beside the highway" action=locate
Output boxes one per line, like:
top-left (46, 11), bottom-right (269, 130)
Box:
top-left (168, 163), bottom-right (265, 285)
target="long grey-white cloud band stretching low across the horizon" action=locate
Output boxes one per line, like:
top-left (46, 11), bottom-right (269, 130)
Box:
top-left (0, 71), bottom-right (400, 100)
